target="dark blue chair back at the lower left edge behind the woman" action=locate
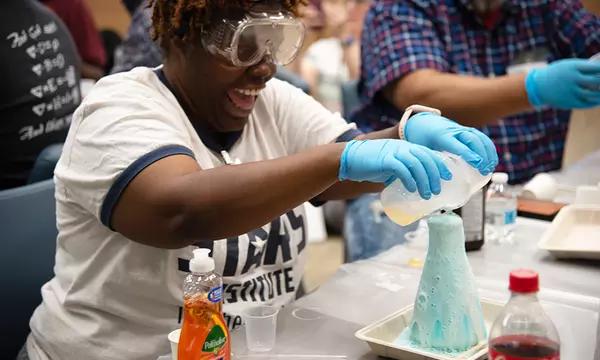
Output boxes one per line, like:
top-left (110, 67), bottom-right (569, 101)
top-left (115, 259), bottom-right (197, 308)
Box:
top-left (0, 180), bottom-right (57, 359)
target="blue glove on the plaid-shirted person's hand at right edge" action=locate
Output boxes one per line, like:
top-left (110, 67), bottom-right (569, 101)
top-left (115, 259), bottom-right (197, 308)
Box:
top-left (525, 59), bottom-right (600, 109)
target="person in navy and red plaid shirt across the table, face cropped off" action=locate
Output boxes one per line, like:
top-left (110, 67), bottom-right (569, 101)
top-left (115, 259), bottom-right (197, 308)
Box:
top-left (346, 0), bottom-right (600, 260)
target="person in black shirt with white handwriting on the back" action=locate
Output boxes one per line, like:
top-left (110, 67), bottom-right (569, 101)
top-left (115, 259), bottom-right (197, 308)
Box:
top-left (0, 0), bottom-right (81, 189)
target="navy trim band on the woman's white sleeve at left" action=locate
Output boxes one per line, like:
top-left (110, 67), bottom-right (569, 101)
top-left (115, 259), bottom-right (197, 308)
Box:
top-left (100, 145), bottom-right (194, 230)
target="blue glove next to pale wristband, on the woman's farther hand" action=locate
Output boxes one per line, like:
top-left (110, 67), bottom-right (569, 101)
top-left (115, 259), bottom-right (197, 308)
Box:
top-left (404, 112), bottom-right (498, 175)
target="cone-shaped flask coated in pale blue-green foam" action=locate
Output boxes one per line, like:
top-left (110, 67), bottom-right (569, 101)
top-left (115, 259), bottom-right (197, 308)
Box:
top-left (394, 215), bottom-right (487, 354)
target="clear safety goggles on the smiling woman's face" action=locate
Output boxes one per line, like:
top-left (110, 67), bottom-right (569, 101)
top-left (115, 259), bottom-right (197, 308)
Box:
top-left (202, 12), bottom-right (304, 67)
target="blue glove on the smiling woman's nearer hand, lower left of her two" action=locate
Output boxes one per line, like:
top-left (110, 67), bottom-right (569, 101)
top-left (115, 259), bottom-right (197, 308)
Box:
top-left (338, 140), bottom-right (452, 199)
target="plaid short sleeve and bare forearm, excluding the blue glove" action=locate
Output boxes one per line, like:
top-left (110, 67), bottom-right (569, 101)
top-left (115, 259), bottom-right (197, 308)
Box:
top-left (363, 1), bottom-right (530, 126)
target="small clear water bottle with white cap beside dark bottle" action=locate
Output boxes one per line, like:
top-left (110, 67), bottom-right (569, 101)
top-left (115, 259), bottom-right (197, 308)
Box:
top-left (485, 173), bottom-right (517, 243)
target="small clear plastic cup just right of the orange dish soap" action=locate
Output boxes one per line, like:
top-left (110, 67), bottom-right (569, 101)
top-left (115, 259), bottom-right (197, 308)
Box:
top-left (243, 305), bottom-right (279, 352)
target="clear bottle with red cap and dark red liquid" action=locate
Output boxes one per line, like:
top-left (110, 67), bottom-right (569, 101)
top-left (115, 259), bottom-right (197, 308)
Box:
top-left (489, 269), bottom-right (560, 360)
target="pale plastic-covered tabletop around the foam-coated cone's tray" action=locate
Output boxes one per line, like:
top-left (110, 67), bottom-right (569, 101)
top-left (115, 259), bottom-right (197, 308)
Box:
top-left (232, 218), bottom-right (600, 360)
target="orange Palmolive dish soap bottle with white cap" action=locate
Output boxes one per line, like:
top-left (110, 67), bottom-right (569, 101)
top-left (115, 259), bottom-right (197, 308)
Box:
top-left (177, 249), bottom-right (231, 360)
